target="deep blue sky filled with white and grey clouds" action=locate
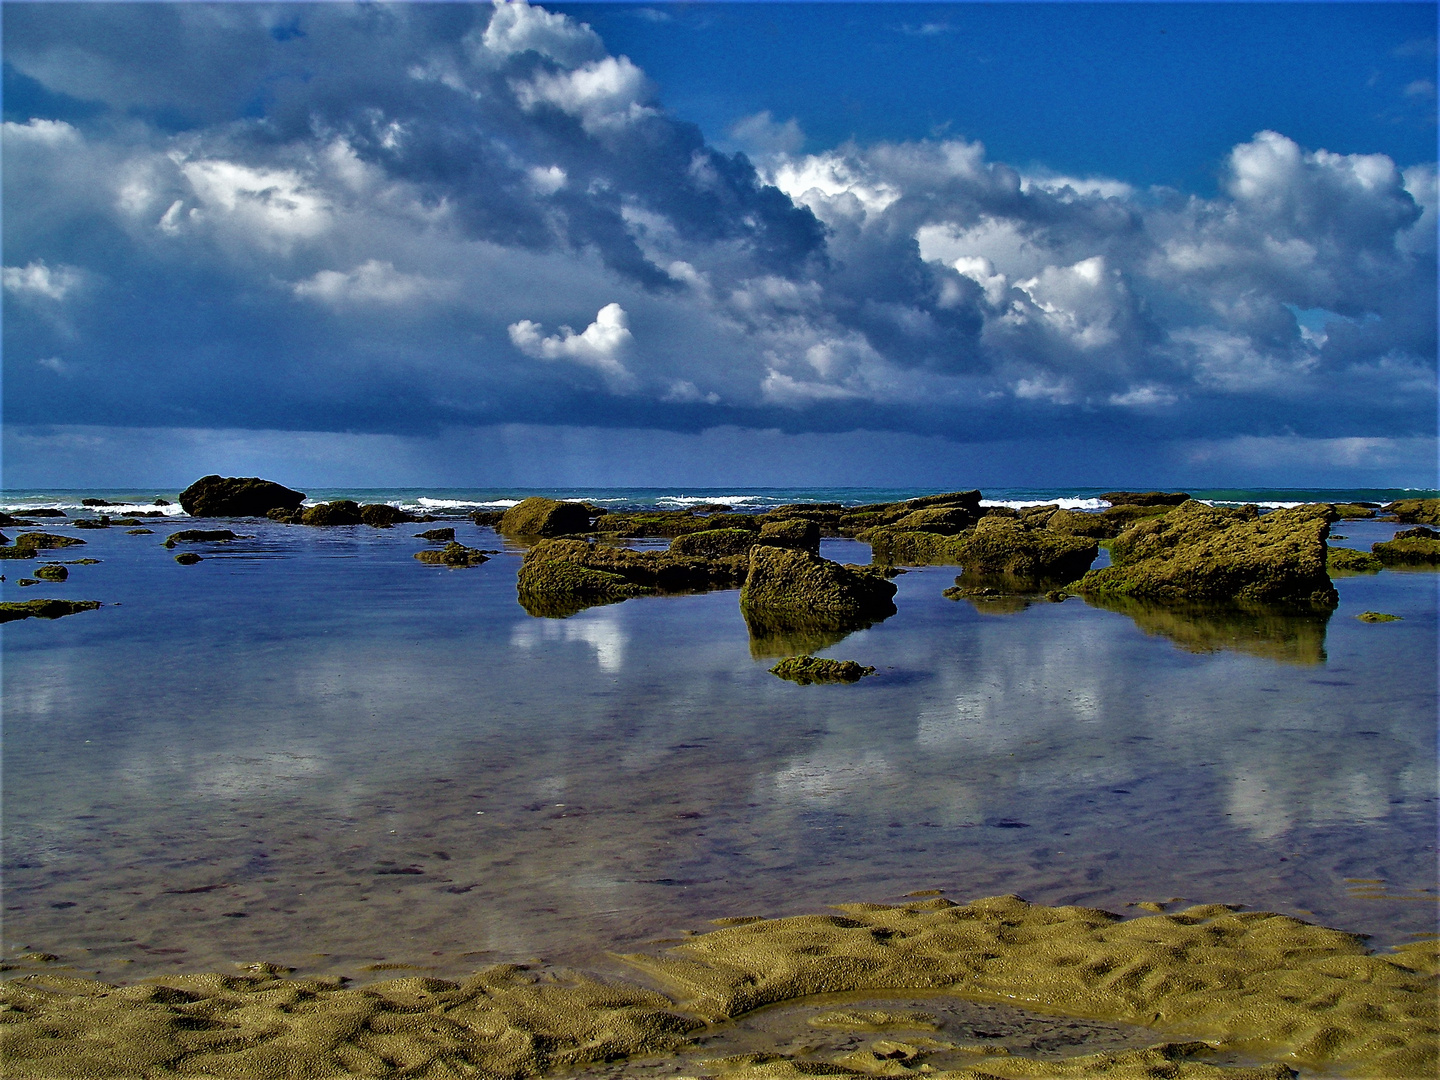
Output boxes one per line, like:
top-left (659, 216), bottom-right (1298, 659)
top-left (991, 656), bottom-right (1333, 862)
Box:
top-left (3, 0), bottom-right (1437, 488)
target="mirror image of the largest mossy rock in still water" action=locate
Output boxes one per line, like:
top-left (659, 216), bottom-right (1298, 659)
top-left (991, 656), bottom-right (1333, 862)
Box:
top-left (1084, 596), bottom-right (1331, 664)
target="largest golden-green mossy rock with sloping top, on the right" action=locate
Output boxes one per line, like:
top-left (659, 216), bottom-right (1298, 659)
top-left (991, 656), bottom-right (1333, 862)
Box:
top-left (1076, 501), bottom-right (1336, 608)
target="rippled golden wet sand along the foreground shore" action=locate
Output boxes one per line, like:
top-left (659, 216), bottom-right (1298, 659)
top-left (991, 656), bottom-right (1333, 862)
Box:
top-left (0, 896), bottom-right (1440, 1080)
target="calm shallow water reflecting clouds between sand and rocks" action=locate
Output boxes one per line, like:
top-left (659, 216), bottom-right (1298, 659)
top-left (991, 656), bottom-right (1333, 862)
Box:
top-left (0, 521), bottom-right (1437, 979)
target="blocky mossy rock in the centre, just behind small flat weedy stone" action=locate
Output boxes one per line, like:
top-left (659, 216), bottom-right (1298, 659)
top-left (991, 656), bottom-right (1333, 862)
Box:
top-left (740, 546), bottom-right (896, 624)
